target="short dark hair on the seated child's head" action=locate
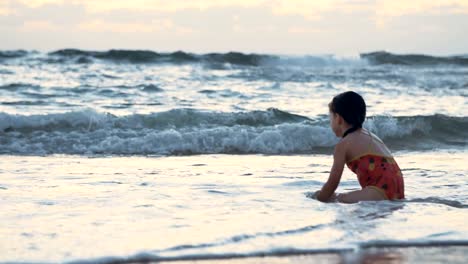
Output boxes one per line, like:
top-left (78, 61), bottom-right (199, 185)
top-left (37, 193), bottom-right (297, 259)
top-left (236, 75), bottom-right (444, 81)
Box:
top-left (328, 91), bottom-right (366, 133)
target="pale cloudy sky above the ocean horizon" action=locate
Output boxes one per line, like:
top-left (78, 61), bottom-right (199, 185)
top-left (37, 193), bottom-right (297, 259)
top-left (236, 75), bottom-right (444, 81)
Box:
top-left (0, 0), bottom-right (468, 56)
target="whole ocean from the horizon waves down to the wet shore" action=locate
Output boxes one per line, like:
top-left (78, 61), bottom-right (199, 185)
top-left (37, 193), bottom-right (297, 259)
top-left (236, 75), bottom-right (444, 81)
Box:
top-left (0, 49), bottom-right (468, 263)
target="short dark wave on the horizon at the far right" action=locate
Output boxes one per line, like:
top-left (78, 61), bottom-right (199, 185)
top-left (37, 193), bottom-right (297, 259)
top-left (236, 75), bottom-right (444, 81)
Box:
top-left (360, 51), bottom-right (468, 66)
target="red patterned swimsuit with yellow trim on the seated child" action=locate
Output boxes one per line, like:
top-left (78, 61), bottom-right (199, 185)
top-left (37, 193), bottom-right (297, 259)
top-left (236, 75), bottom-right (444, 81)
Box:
top-left (346, 136), bottom-right (405, 200)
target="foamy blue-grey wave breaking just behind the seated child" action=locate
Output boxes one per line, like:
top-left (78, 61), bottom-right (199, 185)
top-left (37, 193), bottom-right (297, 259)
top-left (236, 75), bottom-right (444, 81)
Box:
top-left (0, 109), bottom-right (468, 155)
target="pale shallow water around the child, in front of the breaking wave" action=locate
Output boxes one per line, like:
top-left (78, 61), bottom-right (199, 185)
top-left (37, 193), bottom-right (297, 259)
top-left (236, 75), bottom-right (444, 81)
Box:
top-left (0, 151), bottom-right (468, 262)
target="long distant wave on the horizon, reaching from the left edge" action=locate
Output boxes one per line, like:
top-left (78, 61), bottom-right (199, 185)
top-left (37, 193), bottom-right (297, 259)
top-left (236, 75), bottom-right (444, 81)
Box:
top-left (0, 49), bottom-right (356, 67)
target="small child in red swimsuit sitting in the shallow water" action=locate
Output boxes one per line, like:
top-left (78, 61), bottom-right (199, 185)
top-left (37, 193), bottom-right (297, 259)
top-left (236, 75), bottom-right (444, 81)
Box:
top-left (314, 91), bottom-right (405, 203)
